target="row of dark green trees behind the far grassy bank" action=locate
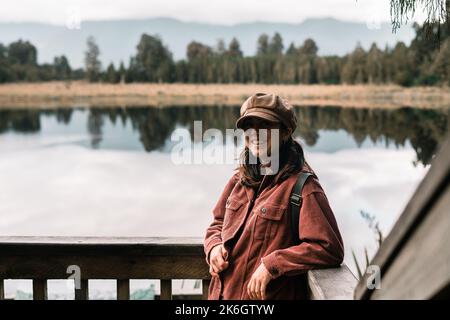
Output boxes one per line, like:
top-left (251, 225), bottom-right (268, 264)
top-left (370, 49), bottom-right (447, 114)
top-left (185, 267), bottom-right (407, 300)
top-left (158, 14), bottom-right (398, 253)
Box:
top-left (0, 23), bottom-right (450, 86)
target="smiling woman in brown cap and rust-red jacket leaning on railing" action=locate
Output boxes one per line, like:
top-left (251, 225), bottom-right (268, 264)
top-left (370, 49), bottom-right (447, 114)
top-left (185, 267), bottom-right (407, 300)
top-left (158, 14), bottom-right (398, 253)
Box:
top-left (204, 93), bottom-right (344, 300)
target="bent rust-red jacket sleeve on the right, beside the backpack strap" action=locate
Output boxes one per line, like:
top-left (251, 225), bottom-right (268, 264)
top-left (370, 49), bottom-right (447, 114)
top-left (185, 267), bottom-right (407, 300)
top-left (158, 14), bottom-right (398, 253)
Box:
top-left (261, 191), bottom-right (344, 278)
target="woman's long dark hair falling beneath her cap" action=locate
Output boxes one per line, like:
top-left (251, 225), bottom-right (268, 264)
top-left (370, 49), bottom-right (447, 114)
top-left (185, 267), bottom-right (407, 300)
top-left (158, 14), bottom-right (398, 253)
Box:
top-left (237, 128), bottom-right (305, 188)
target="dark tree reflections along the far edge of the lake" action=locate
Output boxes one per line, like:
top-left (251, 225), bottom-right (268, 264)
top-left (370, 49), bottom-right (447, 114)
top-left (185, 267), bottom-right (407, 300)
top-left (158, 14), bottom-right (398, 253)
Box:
top-left (0, 106), bottom-right (450, 165)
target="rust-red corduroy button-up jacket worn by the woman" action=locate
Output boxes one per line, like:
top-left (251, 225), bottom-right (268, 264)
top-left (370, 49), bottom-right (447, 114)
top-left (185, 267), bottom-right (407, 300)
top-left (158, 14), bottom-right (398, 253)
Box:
top-left (204, 164), bottom-right (344, 300)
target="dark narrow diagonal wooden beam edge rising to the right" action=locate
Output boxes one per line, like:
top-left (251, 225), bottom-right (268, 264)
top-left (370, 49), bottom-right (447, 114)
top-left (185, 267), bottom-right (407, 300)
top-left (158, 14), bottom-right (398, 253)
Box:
top-left (355, 134), bottom-right (450, 299)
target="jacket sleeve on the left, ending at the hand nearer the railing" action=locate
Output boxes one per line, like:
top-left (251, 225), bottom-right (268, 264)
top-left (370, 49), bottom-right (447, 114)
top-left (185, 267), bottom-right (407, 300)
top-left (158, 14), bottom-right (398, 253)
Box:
top-left (203, 174), bottom-right (237, 265)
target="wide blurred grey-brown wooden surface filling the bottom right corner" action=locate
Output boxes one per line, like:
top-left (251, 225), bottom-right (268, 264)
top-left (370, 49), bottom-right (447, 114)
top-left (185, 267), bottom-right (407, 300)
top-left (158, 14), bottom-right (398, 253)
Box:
top-left (371, 185), bottom-right (450, 299)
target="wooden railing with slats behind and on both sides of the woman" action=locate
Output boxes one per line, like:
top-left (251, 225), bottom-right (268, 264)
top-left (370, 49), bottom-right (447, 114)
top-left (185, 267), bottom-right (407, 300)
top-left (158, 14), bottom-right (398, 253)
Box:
top-left (0, 237), bottom-right (356, 300)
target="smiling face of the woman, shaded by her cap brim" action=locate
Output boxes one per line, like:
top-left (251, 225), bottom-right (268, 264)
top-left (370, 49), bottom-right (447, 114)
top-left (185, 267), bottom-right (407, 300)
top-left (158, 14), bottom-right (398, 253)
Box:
top-left (243, 117), bottom-right (281, 157)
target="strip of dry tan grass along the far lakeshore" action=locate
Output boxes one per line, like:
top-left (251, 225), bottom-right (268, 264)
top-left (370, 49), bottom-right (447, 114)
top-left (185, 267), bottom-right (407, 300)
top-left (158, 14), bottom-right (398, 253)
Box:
top-left (0, 81), bottom-right (450, 108)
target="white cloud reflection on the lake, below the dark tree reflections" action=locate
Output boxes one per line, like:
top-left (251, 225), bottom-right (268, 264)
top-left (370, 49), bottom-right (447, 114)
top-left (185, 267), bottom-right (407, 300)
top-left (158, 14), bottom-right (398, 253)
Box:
top-left (0, 138), bottom-right (428, 272)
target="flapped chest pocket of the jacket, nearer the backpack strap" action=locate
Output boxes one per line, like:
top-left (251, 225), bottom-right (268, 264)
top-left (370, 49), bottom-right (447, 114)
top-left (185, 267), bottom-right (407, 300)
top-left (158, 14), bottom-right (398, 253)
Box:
top-left (253, 204), bottom-right (286, 240)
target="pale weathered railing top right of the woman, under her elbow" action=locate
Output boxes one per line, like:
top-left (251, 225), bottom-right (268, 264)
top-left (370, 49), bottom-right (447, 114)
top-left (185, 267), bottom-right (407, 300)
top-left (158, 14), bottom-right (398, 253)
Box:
top-left (308, 264), bottom-right (357, 300)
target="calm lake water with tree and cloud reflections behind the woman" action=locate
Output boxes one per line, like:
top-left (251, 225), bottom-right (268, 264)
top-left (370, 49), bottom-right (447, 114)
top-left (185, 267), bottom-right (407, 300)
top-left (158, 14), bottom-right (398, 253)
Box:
top-left (0, 106), bottom-right (450, 298)
